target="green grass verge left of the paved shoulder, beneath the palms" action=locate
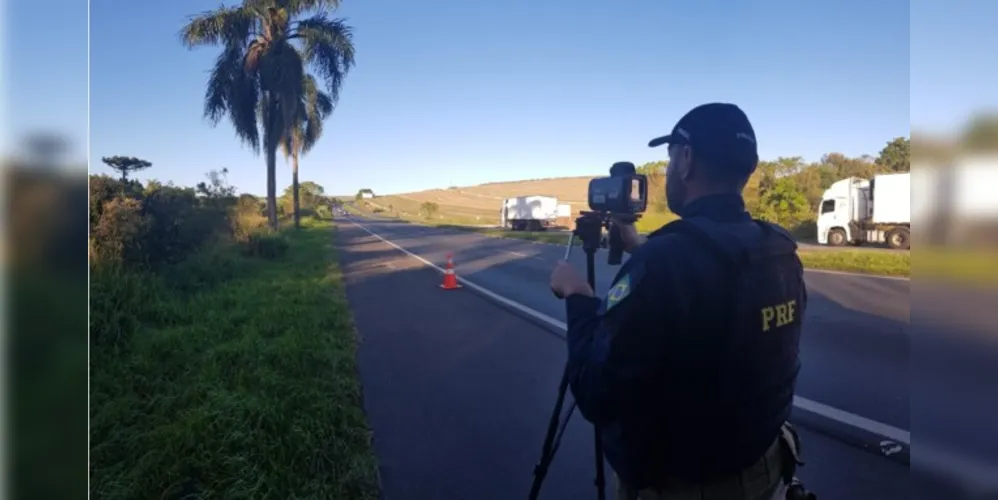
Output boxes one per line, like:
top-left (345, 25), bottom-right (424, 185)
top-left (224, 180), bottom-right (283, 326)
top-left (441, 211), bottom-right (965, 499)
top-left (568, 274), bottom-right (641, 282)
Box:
top-left (90, 220), bottom-right (378, 499)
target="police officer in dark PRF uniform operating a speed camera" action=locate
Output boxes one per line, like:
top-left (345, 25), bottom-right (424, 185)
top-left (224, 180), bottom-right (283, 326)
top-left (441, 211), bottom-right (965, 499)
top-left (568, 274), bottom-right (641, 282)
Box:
top-left (551, 103), bottom-right (807, 500)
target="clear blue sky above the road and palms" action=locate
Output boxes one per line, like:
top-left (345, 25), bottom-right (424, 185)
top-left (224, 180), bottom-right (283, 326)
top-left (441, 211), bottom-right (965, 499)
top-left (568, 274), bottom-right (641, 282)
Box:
top-left (5, 0), bottom-right (998, 194)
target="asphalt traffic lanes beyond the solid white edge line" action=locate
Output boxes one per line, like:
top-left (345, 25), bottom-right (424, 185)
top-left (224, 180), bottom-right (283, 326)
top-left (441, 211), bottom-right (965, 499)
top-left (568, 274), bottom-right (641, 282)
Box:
top-left (342, 220), bottom-right (910, 430)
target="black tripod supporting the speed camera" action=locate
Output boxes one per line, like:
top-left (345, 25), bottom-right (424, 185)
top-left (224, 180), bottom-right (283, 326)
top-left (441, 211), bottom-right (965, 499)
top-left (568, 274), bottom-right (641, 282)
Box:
top-left (529, 212), bottom-right (623, 500)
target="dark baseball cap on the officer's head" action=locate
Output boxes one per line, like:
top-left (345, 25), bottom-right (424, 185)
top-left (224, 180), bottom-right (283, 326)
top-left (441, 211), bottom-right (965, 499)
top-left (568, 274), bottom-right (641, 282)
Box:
top-left (648, 102), bottom-right (759, 173)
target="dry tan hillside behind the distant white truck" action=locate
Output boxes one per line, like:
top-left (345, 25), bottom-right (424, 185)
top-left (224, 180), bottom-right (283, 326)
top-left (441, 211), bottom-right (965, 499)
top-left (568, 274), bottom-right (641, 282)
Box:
top-left (368, 177), bottom-right (592, 225)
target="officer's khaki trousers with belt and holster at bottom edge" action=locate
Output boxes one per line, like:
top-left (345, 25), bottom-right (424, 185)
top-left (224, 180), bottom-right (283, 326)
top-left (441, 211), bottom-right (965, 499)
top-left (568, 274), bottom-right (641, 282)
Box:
top-left (617, 424), bottom-right (818, 500)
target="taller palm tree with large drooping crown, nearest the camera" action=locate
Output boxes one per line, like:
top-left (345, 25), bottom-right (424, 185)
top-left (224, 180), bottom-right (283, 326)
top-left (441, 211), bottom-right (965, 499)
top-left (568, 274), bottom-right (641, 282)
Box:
top-left (180, 0), bottom-right (354, 229)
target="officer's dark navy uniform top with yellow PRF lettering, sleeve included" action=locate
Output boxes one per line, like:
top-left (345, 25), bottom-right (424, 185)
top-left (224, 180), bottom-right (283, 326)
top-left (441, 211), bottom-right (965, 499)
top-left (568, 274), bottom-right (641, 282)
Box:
top-left (566, 195), bottom-right (807, 489)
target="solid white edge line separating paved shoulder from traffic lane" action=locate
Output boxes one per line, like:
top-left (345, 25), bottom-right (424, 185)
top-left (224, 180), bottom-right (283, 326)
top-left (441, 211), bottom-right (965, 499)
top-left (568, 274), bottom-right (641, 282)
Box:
top-left (353, 222), bottom-right (911, 438)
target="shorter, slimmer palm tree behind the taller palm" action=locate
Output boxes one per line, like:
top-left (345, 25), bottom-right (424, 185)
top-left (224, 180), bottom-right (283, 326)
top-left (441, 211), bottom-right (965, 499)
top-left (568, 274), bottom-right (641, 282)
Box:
top-left (281, 75), bottom-right (334, 229)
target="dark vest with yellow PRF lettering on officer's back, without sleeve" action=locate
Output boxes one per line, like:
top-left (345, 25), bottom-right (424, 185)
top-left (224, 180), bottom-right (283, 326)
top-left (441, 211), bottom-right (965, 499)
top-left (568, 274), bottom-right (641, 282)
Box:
top-left (622, 217), bottom-right (807, 485)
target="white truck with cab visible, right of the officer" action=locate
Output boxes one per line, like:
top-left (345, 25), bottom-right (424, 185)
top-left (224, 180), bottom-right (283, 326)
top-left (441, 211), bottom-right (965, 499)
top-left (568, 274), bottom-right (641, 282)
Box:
top-left (817, 173), bottom-right (911, 250)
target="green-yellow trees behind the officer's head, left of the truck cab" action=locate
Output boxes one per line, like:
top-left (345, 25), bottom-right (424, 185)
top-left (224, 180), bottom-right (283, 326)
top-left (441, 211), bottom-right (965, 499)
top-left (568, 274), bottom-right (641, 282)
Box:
top-left (637, 137), bottom-right (911, 237)
